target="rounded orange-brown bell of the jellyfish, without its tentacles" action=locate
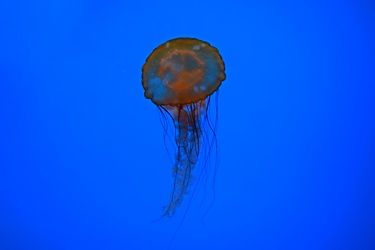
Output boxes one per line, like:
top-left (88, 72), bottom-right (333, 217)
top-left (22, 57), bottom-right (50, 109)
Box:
top-left (142, 38), bottom-right (225, 106)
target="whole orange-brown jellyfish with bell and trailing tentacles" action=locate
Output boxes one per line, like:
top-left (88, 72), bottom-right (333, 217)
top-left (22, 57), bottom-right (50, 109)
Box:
top-left (142, 38), bottom-right (226, 217)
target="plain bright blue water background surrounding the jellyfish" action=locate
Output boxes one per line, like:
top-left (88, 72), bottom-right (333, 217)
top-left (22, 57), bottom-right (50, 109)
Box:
top-left (0, 0), bottom-right (375, 250)
